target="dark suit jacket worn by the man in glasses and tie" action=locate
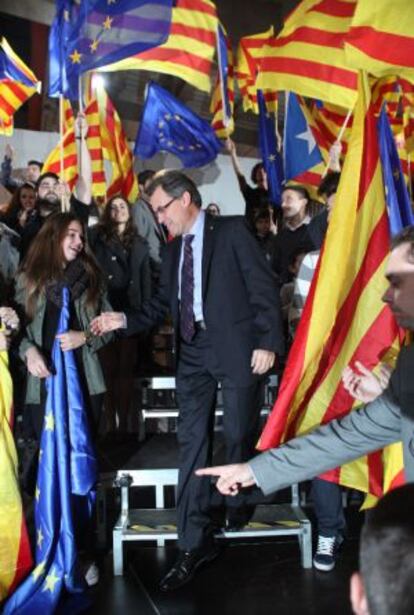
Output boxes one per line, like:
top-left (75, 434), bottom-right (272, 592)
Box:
top-left (127, 214), bottom-right (284, 385)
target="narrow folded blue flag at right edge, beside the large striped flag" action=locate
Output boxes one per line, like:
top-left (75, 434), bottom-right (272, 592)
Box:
top-left (378, 106), bottom-right (414, 237)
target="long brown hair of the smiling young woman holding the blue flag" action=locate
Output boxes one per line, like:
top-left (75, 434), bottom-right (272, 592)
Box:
top-left (21, 213), bottom-right (102, 318)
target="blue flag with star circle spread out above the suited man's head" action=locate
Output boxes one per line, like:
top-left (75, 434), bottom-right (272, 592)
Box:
top-left (134, 81), bottom-right (222, 167)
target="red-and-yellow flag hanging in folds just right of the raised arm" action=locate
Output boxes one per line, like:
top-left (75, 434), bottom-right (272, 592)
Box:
top-left (95, 87), bottom-right (139, 203)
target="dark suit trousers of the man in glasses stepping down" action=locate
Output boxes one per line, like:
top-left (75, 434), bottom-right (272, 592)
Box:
top-left (176, 331), bottom-right (264, 551)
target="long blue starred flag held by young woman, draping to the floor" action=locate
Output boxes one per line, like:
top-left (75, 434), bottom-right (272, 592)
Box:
top-left (4, 288), bottom-right (98, 615)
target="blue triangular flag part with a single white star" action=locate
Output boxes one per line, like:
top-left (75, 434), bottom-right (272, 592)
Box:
top-left (283, 92), bottom-right (323, 180)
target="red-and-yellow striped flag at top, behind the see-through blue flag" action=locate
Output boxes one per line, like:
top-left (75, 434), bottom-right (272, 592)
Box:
top-left (100, 0), bottom-right (218, 92)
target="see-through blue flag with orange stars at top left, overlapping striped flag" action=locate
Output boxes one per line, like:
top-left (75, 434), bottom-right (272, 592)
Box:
top-left (66, 0), bottom-right (173, 98)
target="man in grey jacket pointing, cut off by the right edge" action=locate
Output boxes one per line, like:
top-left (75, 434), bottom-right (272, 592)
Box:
top-left (197, 226), bottom-right (414, 495)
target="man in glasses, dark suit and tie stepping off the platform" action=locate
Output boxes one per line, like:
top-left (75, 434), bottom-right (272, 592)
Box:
top-left (93, 171), bottom-right (283, 591)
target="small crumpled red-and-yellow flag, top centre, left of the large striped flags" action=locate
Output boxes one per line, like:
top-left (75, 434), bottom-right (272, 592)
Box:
top-left (235, 27), bottom-right (278, 114)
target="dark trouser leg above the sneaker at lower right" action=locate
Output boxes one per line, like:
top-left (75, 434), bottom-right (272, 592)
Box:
top-left (312, 478), bottom-right (346, 536)
